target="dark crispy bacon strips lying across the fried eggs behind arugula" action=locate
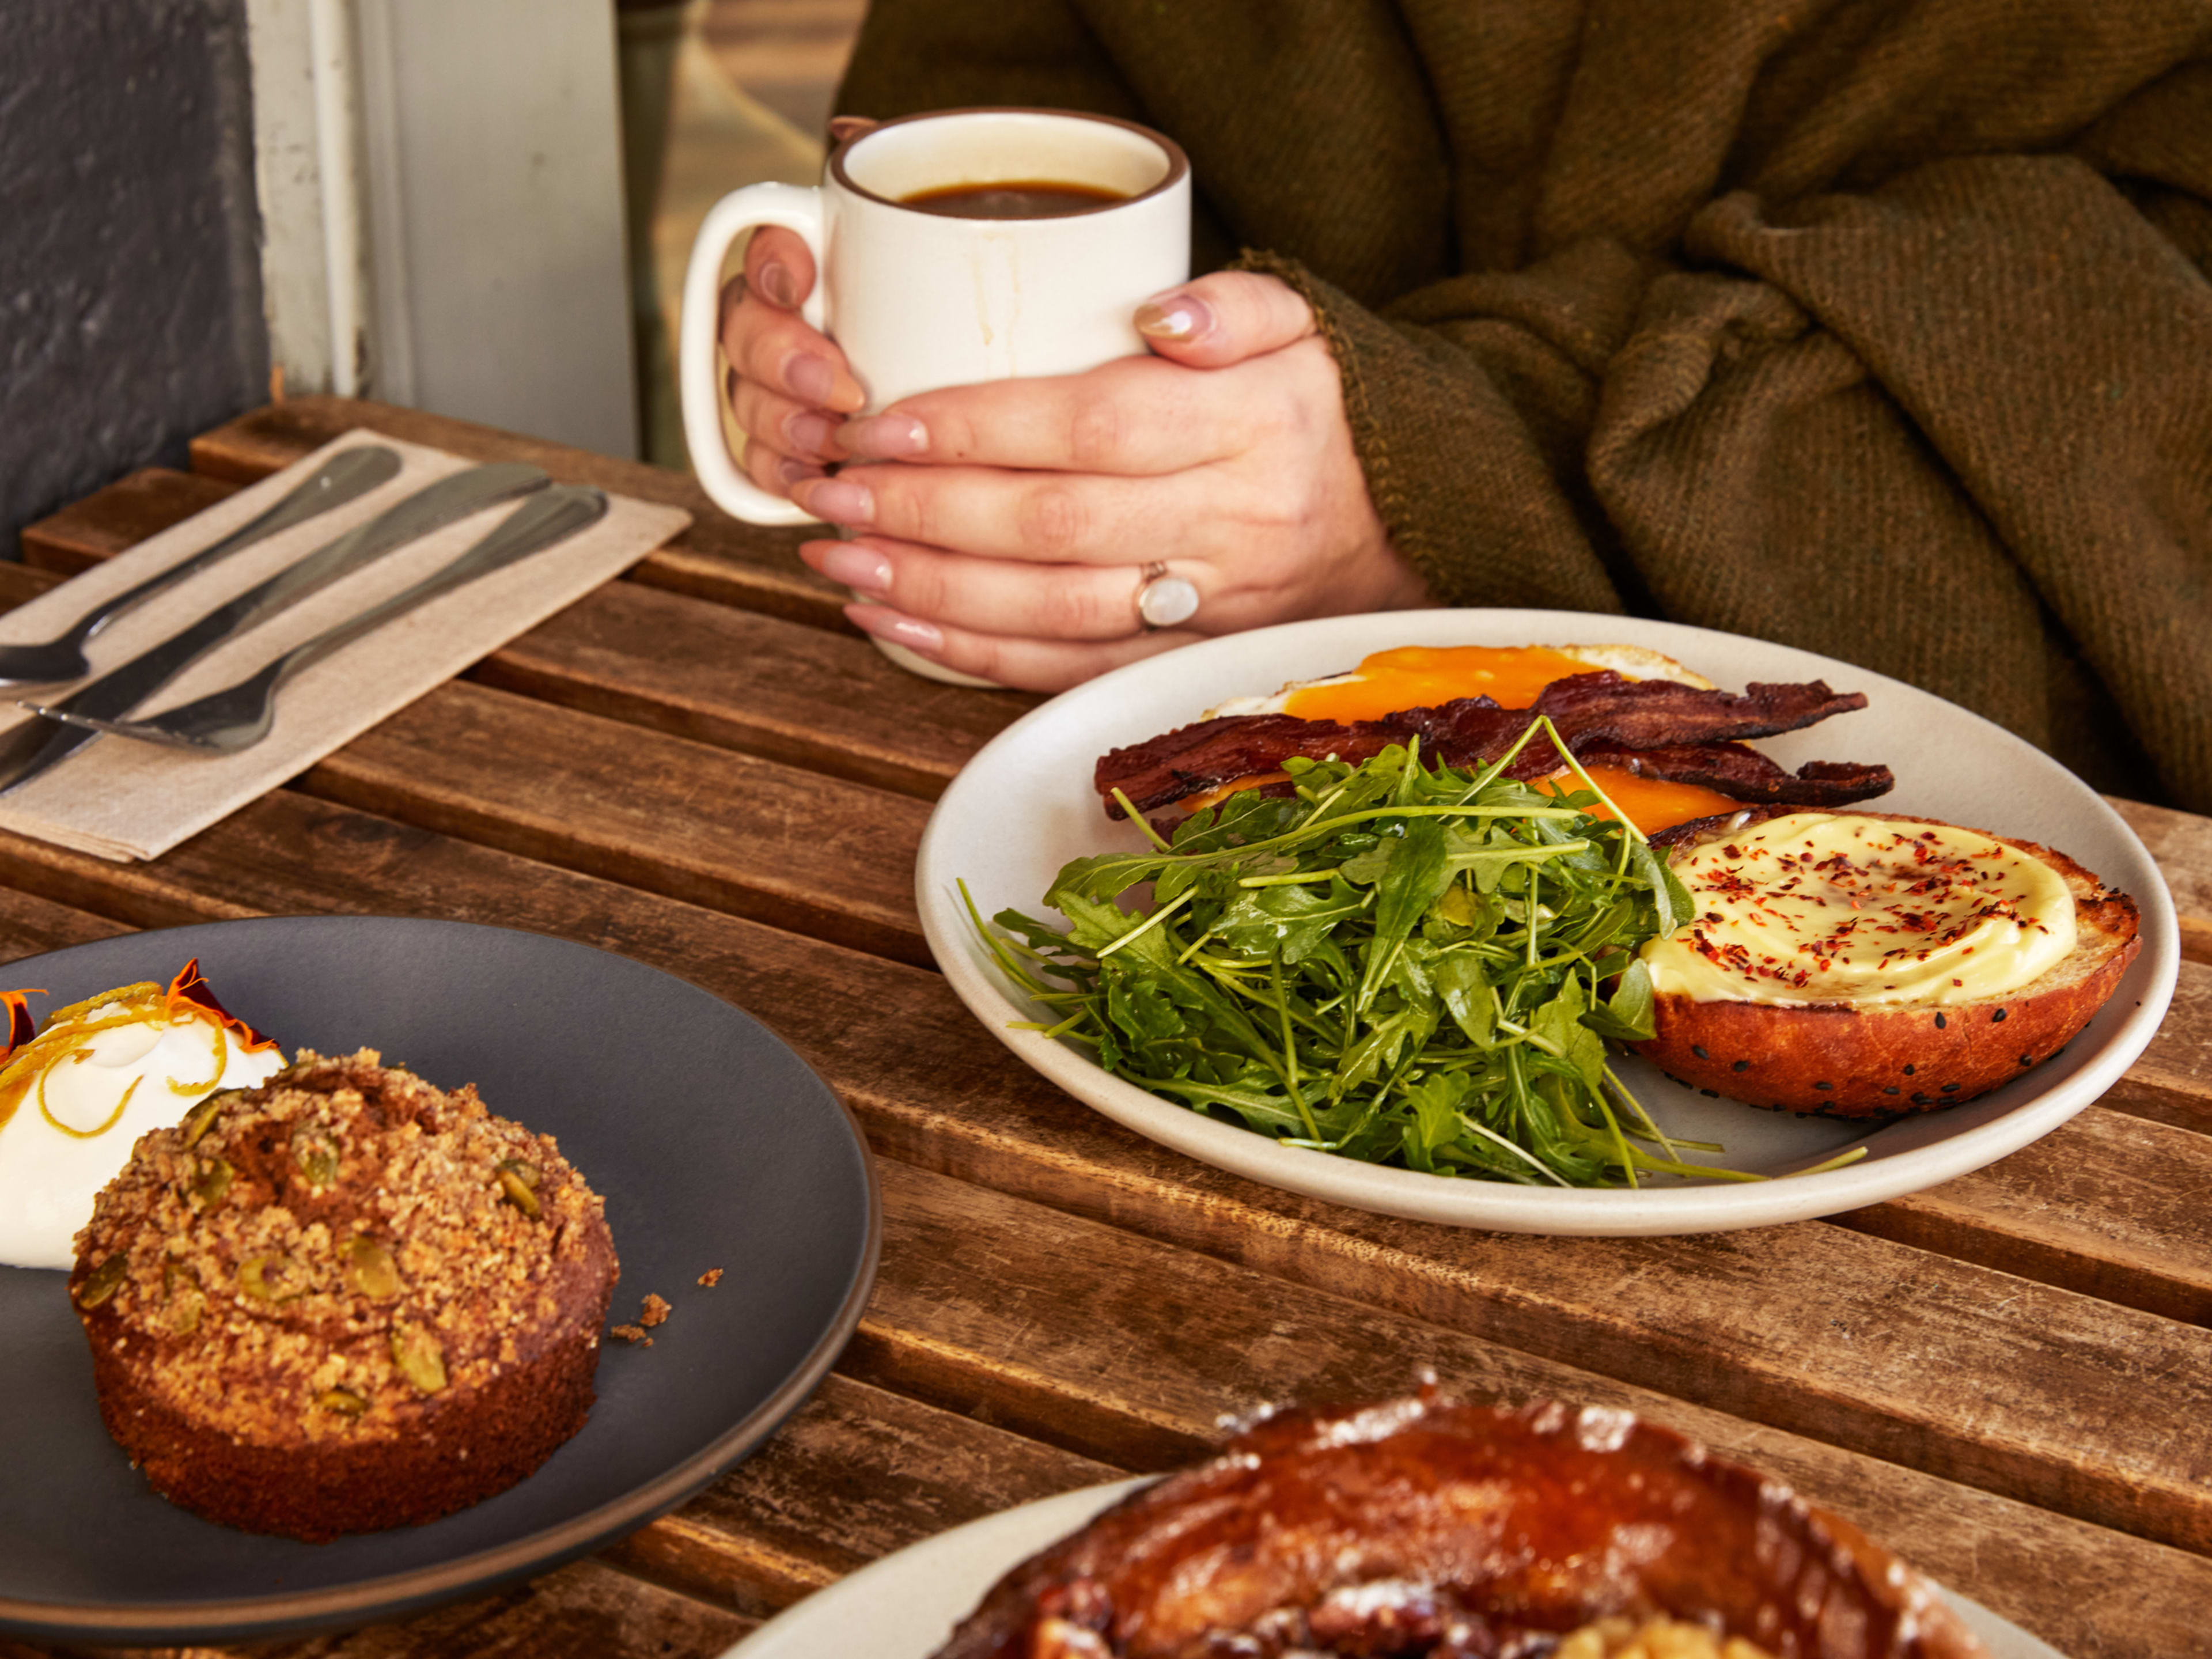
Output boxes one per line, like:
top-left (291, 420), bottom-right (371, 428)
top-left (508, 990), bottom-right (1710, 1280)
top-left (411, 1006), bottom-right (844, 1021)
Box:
top-left (1093, 671), bottom-right (1891, 819)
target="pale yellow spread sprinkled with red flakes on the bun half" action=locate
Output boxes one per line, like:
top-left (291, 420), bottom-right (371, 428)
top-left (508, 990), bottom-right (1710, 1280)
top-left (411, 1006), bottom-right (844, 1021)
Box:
top-left (1643, 812), bottom-right (2075, 1009)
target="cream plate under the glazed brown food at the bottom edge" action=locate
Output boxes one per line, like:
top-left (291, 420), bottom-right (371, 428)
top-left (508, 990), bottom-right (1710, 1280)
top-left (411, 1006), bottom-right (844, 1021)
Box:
top-left (724, 1480), bottom-right (2064, 1659)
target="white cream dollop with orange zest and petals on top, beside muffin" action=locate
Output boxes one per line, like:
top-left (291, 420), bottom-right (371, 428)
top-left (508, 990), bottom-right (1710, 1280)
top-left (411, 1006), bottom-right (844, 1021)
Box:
top-left (0, 964), bottom-right (283, 1270)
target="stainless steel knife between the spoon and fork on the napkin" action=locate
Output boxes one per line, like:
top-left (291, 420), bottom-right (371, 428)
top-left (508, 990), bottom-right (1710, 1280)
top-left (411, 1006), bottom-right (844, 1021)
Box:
top-left (0, 463), bottom-right (551, 794)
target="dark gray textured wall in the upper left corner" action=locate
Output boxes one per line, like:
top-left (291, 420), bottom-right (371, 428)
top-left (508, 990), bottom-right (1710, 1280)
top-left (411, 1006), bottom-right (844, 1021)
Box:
top-left (0, 0), bottom-right (268, 558)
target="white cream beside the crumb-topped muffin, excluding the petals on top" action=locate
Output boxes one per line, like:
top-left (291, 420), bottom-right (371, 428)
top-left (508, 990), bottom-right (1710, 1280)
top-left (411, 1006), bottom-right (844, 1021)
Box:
top-left (0, 1004), bottom-right (283, 1270)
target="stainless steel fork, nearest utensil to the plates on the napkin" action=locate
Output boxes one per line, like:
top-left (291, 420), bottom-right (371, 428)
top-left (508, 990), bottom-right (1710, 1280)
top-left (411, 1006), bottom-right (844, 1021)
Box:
top-left (24, 484), bottom-right (606, 754)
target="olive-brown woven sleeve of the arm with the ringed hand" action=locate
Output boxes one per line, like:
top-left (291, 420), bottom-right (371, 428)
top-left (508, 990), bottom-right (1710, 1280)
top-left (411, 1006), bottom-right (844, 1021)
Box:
top-left (1245, 69), bottom-right (2212, 812)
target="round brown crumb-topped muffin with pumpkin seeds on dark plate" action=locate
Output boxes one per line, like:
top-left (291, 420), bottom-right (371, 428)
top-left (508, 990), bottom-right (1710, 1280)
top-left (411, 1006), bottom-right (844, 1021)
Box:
top-left (69, 1048), bottom-right (617, 1540)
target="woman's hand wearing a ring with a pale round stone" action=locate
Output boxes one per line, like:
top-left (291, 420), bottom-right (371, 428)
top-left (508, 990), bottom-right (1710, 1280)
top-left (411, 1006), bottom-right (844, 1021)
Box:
top-left (787, 272), bottom-right (1427, 690)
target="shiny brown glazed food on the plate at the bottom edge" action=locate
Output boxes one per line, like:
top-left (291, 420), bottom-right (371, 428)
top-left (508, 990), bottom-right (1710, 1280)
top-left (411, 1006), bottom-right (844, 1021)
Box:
top-left (938, 1393), bottom-right (1986, 1659)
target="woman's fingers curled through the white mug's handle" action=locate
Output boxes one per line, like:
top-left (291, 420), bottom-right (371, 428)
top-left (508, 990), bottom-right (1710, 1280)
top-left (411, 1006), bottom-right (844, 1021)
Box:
top-left (721, 226), bottom-right (867, 495)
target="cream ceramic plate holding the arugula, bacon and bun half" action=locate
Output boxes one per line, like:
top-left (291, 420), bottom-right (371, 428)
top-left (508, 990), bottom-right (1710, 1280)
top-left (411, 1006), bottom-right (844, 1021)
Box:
top-left (916, 611), bottom-right (2181, 1234)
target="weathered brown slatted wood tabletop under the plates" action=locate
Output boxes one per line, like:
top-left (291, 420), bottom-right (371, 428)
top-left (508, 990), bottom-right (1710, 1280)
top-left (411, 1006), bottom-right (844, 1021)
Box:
top-left (0, 398), bottom-right (2212, 1659)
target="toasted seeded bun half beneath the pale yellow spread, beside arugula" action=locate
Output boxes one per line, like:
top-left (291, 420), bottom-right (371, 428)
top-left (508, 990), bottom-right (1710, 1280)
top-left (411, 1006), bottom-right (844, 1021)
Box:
top-left (1633, 812), bottom-right (2143, 1117)
